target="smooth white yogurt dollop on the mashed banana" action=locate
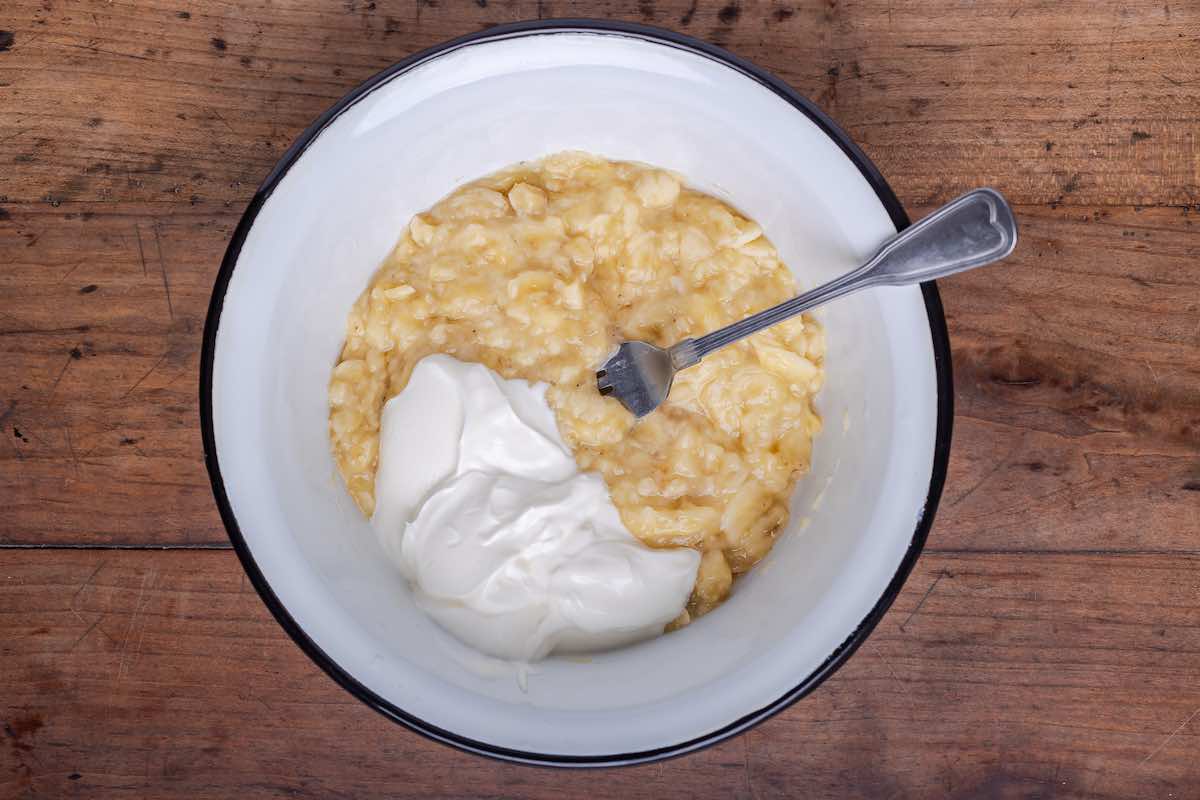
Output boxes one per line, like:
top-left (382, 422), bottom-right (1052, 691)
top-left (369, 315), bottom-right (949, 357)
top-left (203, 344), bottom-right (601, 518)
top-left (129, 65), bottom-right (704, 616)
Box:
top-left (371, 355), bottom-right (700, 661)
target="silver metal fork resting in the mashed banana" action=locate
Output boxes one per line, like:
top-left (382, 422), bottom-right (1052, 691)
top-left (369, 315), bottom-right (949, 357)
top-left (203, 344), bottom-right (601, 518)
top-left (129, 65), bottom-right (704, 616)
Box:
top-left (596, 188), bottom-right (1016, 416)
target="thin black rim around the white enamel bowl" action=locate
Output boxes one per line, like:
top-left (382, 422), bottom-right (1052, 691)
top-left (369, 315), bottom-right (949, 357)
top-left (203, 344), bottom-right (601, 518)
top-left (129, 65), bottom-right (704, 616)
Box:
top-left (200, 19), bottom-right (954, 766)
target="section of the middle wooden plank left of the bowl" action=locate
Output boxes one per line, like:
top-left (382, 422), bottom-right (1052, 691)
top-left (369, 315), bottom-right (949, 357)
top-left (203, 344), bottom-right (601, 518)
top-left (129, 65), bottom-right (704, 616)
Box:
top-left (0, 204), bottom-right (236, 545)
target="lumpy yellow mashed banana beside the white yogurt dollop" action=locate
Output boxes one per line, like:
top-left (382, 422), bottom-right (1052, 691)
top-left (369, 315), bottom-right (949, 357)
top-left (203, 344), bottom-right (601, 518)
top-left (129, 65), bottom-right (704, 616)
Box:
top-left (329, 152), bottom-right (824, 625)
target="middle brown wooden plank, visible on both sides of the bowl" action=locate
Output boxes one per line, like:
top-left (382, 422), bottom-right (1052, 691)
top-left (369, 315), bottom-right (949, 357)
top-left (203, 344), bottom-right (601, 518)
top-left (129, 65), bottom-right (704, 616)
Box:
top-left (0, 203), bottom-right (1200, 552)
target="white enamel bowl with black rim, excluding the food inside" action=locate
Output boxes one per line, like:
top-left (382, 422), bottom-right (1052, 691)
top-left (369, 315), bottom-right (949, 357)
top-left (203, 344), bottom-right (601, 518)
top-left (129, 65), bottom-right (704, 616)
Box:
top-left (200, 20), bottom-right (952, 765)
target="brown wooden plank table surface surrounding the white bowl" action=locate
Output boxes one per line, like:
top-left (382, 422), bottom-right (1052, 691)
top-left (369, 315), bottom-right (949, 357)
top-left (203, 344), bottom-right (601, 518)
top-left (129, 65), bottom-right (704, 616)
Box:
top-left (0, 0), bottom-right (1200, 800)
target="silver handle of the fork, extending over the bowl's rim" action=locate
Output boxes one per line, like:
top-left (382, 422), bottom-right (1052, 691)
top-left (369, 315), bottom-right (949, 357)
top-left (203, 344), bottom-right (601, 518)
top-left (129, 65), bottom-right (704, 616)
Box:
top-left (670, 188), bottom-right (1016, 369)
